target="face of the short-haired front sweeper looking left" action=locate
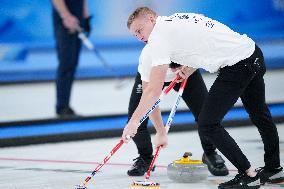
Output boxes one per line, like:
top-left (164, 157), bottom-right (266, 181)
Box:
top-left (129, 15), bottom-right (155, 43)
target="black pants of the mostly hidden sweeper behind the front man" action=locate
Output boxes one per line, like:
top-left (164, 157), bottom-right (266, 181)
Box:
top-left (128, 71), bottom-right (216, 158)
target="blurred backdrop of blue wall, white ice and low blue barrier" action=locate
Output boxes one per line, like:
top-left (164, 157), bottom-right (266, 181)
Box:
top-left (0, 0), bottom-right (284, 146)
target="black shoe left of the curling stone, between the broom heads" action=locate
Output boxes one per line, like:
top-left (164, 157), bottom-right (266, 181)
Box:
top-left (127, 156), bottom-right (155, 176)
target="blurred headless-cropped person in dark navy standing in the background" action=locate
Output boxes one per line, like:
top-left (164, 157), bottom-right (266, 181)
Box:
top-left (52, 0), bottom-right (91, 118)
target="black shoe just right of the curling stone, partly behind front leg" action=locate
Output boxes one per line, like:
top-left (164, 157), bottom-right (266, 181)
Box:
top-left (202, 152), bottom-right (229, 176)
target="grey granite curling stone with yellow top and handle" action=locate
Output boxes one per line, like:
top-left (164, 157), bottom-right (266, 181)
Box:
top-left (167, 152), bottom-right (208, 183)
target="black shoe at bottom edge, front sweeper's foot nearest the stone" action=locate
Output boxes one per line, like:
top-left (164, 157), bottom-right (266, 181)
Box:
top-left (218, 173), bottom-right (260, 189)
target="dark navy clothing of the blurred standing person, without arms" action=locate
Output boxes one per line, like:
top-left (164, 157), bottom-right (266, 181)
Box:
top-left (52, 0), bottom-right (83, 111)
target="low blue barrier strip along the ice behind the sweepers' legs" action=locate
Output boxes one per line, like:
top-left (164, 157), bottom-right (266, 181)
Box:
top-left (0, 104), bottom-right (284, 140)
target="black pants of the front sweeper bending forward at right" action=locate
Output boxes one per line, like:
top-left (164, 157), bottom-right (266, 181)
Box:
top-left (198, 46), bottom-right (280, 172)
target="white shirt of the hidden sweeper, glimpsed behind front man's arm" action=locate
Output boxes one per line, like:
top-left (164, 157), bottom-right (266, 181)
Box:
top-left (138, 44), bottom-right (176, 82)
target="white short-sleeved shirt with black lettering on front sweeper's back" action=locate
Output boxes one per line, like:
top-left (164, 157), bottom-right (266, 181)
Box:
top-left (148, 13), bottom-right (255, 73)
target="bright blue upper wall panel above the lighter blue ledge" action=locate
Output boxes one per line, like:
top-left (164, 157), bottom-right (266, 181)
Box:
top-left (0, 0), bottom-right (284, 45)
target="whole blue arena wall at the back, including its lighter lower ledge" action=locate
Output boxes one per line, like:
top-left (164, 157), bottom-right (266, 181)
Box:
top-left (0, 0), bottom-right (284, 84)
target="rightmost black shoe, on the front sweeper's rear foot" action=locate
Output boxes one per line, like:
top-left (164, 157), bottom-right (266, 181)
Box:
top-left (256, 167), bottom-right (284, 185)
